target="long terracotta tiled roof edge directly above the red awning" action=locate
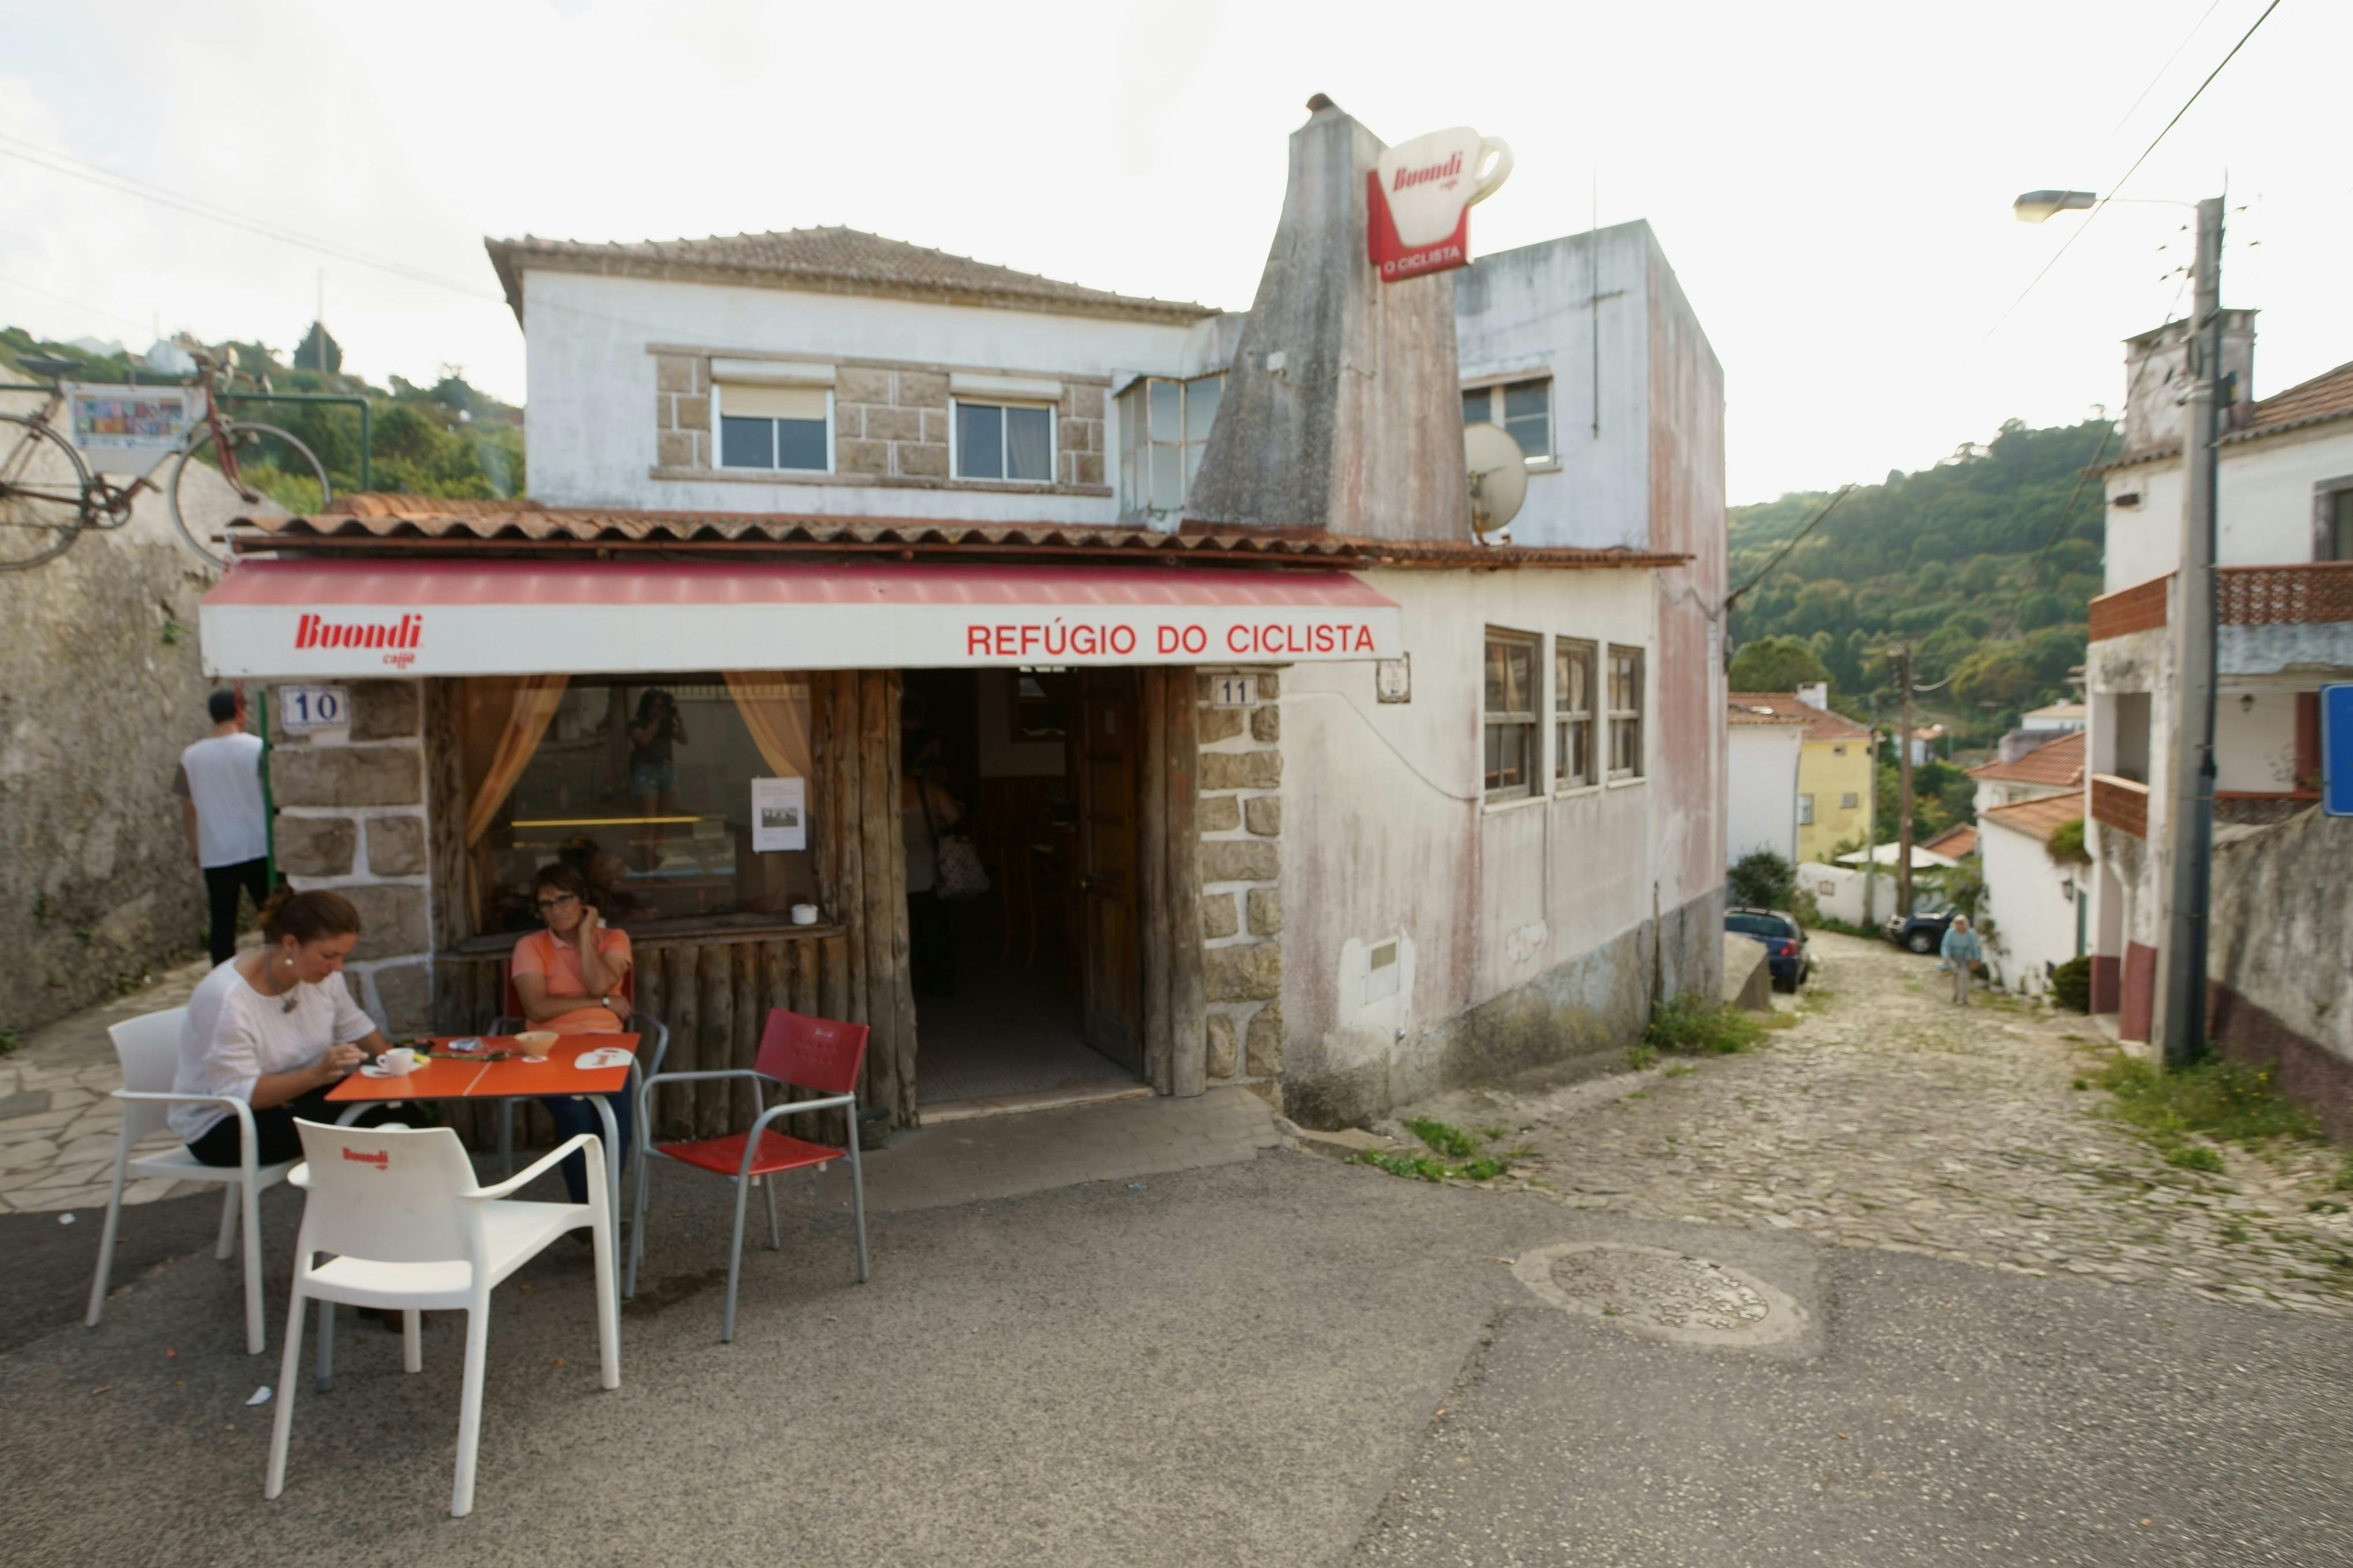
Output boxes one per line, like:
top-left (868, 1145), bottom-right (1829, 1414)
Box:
top-left (231, 494), bottom-right (1689, 571)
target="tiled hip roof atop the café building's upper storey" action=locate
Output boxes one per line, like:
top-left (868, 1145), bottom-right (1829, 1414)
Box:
top-left (482, 228), bottom-right (1216, 327)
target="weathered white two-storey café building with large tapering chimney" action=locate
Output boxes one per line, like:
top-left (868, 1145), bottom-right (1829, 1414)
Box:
top-left (207, 101), bottom-right (1725, 1124)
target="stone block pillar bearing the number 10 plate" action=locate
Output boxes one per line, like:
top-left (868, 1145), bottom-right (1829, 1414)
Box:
top-left (271, 680), bottom-right (433, 1034)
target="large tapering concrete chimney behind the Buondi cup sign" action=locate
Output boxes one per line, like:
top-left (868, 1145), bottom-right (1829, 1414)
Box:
top-left (1186, 94), bottom-right (1471, 543)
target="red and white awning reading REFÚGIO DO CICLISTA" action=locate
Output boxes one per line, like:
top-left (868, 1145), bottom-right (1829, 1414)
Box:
top-left (203, 560), bottom-right (1405, 677)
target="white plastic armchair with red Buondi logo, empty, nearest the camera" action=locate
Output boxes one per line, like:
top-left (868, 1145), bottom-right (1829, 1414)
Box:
top-left (264, 1119), bottom-right (621, 1516)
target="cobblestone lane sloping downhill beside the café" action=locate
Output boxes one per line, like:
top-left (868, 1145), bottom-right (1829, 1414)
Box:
top-left (1383, 933), bottom-right (2353, 1316)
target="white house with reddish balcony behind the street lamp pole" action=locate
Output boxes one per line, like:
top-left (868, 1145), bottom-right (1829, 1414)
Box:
top-left (2087, 310), bottom-right (2353, 1128)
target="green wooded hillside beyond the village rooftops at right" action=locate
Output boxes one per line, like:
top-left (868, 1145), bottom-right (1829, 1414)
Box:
top-left (1732, 421), bottom-right (2113, 745)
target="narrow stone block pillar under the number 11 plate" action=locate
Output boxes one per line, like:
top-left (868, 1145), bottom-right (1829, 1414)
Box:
top-left (1196, 670), bottom-right (1283, 1098)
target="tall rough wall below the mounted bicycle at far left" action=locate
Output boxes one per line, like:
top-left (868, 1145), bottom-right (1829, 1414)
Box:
top-left (0, 395), bottom-right (235, 1034)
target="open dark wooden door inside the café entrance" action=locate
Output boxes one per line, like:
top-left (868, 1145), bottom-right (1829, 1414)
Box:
top-left (1076, 670), bottom-right (1144, 1072)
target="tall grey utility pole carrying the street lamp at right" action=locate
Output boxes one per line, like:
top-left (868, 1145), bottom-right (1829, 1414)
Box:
top-left (2153, 195), bottom-right (2221, 1067)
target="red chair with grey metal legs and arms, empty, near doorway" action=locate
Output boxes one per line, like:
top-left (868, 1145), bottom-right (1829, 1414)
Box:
top-left (624, 1006), bottom-right (866, 1342)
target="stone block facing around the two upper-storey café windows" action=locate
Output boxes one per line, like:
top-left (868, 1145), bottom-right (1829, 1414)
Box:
top-left (654, 348), bottom-right (1111, 496)
